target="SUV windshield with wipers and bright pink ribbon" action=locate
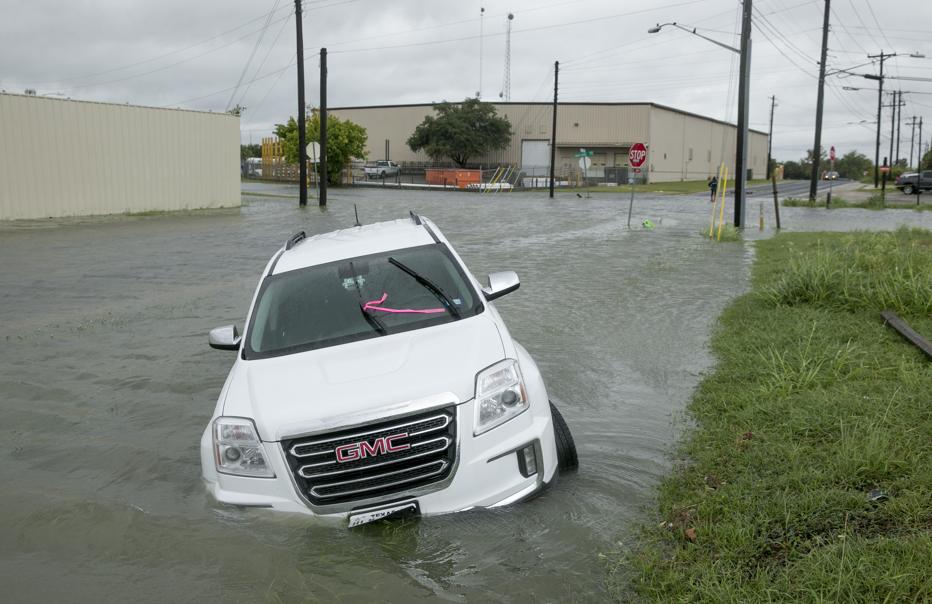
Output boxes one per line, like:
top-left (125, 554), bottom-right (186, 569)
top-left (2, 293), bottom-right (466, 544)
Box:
top-left (244, 243), bottom-right (483, 359)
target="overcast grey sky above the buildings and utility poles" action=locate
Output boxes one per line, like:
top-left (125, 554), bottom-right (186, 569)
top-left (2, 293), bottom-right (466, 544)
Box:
top-left (0, 0), bottom-right (932, 160)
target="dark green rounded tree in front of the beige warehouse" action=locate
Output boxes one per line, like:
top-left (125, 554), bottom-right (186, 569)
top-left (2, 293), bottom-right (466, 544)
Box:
top-left (407, 98), bottom-right (512, 167)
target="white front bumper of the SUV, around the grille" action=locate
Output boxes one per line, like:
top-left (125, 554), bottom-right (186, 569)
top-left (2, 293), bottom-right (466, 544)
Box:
top-left (201, 396), bottom-right (558, 518)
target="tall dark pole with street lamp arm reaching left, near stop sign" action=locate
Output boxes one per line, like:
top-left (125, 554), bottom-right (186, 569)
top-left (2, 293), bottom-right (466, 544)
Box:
top-left (647, 15), bottom-right (751, 228)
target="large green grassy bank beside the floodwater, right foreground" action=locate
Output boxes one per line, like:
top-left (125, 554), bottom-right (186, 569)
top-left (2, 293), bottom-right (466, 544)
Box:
top-left (609, 229), bottom-right (932, 602)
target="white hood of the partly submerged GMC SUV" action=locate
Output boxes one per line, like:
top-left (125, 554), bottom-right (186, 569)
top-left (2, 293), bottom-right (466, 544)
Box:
top-left (223, 312), bottom-right (504, 441)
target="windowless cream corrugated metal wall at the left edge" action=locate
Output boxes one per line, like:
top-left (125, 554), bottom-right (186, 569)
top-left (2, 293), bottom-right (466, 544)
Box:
top-left (0, 94), bottom-right (240, 220)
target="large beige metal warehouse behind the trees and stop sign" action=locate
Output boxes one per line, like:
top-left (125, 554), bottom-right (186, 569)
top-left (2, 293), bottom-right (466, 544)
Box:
top-left (330, 103), bottom-right (767, 182)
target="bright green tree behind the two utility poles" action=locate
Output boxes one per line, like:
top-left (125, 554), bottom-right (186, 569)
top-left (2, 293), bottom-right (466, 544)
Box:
top-left (275, 109), bottom-right (369, 184)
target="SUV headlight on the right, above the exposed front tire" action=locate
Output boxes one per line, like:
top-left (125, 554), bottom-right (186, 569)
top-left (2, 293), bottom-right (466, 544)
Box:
top-left (473, 359), bottom-right (529, 436)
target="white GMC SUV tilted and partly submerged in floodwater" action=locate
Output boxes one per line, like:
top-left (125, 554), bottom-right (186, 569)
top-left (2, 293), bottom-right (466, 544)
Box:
top-left (201, 213), bottom-right (577, 526)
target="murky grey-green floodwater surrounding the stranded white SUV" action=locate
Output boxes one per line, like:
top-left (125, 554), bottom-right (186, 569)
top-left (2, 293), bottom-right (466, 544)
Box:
top-left (0, 185), bottom-right (932, 602)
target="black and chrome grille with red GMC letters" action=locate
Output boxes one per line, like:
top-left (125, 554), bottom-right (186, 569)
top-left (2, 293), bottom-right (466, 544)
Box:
top-left (282, 407), bottom-right (456, 505)
